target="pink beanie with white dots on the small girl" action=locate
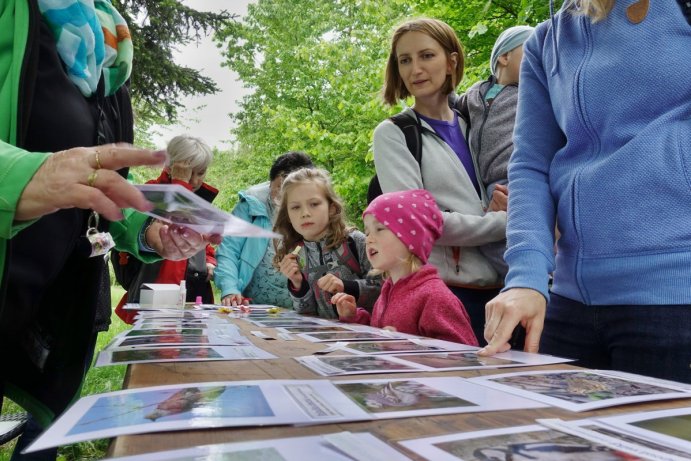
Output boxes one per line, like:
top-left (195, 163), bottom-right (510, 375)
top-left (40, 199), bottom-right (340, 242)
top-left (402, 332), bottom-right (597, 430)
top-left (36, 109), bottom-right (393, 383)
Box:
top-left (362, 189), bottom-right (444, 264)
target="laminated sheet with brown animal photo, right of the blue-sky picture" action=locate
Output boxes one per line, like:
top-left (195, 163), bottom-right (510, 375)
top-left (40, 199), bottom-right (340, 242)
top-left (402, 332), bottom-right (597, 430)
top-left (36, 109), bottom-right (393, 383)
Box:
top-left (332, 377), bottom-right (547, 419)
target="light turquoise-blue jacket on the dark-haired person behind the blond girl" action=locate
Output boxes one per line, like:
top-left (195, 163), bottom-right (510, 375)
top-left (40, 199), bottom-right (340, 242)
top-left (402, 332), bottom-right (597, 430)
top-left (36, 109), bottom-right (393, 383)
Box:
top-left (214, 182), bottom-right (272, 298)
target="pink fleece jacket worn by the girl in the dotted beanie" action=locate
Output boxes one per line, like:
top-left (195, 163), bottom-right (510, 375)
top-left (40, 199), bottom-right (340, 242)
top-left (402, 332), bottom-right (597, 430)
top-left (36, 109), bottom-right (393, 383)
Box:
top-left (340, 264), bottom-right (478, 346)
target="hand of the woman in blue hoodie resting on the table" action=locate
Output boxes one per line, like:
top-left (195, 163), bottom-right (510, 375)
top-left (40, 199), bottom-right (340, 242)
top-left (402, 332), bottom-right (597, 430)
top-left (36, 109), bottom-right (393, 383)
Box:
top-left (477, 288), bottom-right (547, 356)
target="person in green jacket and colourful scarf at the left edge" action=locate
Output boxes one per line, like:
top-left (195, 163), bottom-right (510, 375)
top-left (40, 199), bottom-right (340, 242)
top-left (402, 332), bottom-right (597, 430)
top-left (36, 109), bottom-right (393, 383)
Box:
top-left (0, 0), bottom-right (220, 459)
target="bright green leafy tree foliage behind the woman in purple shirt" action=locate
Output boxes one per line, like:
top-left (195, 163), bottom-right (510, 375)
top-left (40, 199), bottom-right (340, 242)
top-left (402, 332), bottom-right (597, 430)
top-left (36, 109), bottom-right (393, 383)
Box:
top-left (215, 0), bottom-right (548, 222)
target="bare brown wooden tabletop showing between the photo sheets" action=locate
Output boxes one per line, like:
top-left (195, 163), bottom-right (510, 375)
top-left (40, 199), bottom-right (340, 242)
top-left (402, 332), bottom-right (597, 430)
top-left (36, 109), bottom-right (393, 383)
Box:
top-left (109, 312), bottom-right (691, 459)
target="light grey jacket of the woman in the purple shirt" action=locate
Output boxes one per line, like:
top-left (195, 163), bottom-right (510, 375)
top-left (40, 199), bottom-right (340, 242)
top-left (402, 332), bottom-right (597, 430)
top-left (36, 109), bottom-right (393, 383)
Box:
top-left (373, 109), bottom-right (506, 287)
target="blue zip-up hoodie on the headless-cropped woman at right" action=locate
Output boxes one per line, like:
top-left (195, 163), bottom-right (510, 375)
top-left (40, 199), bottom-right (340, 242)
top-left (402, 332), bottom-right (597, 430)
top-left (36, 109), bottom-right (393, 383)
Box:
top-left (506, 1), bottom-right (691, 305)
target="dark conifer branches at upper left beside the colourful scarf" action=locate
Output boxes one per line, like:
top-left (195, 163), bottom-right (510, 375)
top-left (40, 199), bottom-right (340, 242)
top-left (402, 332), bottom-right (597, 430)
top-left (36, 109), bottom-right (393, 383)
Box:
top-left (113, 0), bottom-right (235, 127)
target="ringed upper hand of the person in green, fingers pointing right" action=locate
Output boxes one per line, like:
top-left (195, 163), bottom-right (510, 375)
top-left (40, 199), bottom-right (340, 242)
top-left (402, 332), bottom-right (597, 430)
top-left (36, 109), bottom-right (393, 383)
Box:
top-left (14, 144), bottom-right (166, 221)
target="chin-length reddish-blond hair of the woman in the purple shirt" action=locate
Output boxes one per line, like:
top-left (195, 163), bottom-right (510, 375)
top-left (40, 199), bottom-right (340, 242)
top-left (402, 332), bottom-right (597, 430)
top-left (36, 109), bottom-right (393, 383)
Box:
top-left (382, 18), bottom-right (465, 106)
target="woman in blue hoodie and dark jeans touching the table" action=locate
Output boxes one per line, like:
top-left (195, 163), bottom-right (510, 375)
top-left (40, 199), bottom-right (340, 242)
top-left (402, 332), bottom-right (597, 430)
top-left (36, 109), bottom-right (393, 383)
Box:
top-left (481, 0), bottom-right (691, 382)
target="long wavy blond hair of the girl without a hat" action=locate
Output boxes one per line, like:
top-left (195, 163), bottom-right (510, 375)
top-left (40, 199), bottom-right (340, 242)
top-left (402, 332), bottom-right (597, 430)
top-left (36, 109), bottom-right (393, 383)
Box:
top-left (274, 168), bottom-right (353, 266)
